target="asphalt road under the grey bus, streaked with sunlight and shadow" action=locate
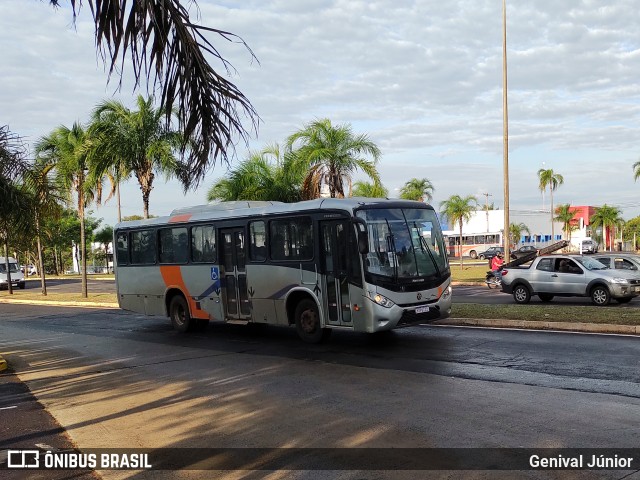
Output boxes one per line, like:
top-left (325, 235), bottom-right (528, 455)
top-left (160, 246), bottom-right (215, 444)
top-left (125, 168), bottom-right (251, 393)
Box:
top-left (0, 304), bottom-right (640, 479)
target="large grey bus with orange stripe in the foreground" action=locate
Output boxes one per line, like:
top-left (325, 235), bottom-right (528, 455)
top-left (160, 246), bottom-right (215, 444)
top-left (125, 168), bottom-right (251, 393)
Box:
top-left (114, 198), bottom-right (451, 343)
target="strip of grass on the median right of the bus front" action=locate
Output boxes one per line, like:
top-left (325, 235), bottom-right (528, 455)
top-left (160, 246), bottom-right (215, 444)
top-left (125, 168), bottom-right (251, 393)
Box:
top-left (451, 304), bottom-right (640, 325)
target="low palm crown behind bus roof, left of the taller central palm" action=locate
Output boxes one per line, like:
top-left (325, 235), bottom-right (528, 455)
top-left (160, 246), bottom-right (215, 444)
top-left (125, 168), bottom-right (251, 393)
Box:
top-left (207, 144), bottom-right (306, 202)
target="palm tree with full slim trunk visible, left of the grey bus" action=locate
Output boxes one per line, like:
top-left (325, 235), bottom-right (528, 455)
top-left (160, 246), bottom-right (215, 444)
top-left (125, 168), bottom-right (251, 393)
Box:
top-left (35, 122), bottom-right (94, 298)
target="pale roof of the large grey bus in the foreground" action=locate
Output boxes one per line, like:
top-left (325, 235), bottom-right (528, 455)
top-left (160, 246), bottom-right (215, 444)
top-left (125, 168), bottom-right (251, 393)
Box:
top-left (115, 197), bottom-right (433, 229)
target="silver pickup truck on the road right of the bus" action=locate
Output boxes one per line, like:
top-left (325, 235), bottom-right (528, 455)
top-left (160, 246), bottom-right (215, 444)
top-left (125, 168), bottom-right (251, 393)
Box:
top-left (502, 255), bottom-right (640, 305)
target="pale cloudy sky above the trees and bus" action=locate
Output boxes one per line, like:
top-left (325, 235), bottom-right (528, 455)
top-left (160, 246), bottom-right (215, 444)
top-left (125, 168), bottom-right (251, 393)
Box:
top-left (0, 0), bottom-right (640, 227)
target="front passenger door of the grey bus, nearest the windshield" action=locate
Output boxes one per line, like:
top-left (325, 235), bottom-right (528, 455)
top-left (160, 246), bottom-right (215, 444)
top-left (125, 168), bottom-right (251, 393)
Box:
top-left (320, 220), bottom-right (360, 326)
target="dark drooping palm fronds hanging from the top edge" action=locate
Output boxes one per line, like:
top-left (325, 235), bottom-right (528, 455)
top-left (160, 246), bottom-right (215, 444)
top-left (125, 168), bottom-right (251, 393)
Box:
top-left (49, 0), bottom-right (258, 185)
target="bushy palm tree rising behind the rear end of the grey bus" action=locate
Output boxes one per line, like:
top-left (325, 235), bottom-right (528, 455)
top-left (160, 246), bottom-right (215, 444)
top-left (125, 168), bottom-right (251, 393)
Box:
top-left (89, 95), bottom-right (186, 218)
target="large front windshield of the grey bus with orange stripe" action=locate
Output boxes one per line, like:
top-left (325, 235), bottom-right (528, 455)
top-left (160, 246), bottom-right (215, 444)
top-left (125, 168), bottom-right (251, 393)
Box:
top-left (357, 208), bottom-right (448, 279)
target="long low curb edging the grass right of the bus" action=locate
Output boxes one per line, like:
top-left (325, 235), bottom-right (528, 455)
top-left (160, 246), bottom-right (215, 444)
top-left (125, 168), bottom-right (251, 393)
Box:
top-left (435, 318), bottom-right (640, 335)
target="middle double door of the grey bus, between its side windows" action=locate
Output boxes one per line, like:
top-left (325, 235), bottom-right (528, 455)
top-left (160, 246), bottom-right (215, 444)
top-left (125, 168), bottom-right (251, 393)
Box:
top-left (220, 228), bottom-right (251, 320)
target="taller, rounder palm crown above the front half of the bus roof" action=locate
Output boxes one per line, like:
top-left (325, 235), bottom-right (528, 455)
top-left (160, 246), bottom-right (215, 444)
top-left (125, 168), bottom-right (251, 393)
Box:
top-left (287, 118), bottom-right (380, 199)
